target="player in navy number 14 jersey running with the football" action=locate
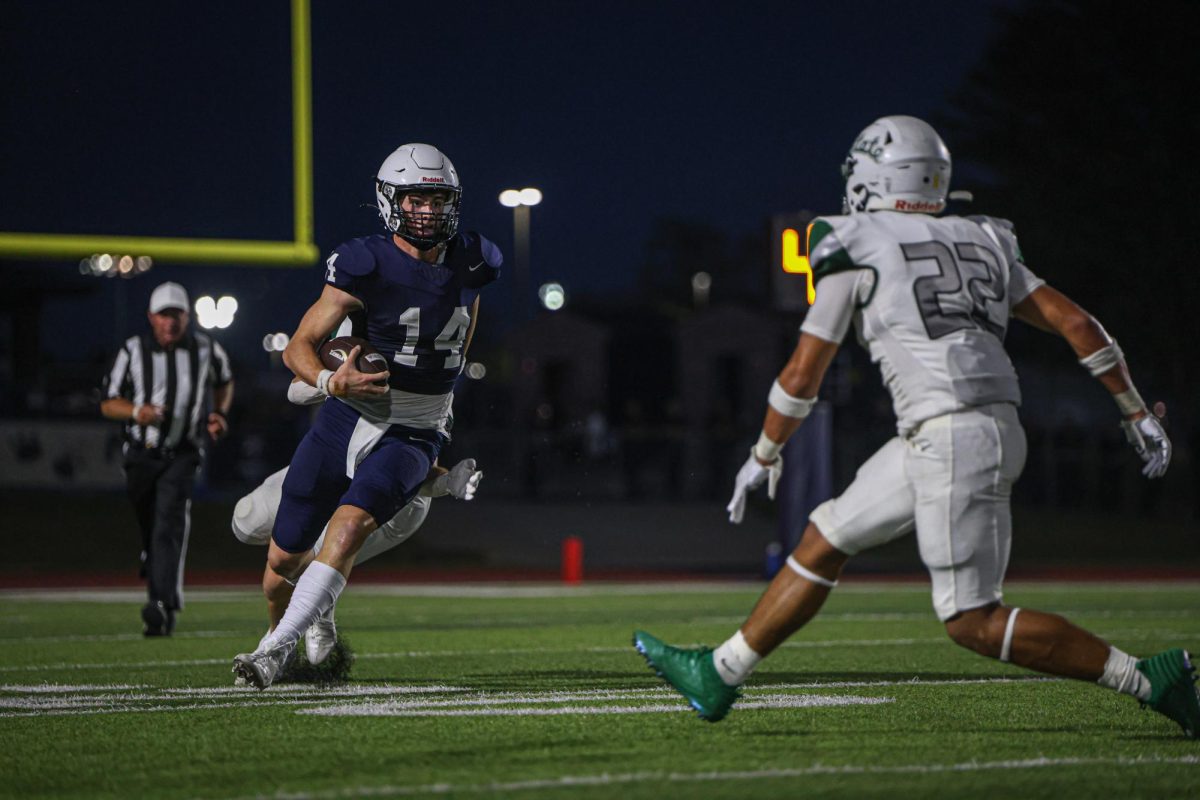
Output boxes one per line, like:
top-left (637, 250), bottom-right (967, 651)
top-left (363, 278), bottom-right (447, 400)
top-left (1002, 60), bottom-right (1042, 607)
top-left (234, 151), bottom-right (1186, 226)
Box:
top-left (234, 144), bottom-right (502, 688)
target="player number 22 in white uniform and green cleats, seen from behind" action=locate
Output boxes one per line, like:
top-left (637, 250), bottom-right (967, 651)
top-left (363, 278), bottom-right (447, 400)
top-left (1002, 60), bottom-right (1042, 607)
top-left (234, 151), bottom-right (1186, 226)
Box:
top-left (634, 116), bottom-right (1200, 738)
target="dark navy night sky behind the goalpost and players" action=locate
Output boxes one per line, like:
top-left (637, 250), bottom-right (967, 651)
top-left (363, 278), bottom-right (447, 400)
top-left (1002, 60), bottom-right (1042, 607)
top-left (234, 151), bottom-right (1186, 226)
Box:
top-left (0, 0), bottom-right (1012, 367)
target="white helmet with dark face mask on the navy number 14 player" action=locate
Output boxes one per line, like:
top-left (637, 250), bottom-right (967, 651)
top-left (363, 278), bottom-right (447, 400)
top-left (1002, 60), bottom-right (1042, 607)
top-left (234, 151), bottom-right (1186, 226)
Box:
top-left (376, 143), bottom-right (462, 249)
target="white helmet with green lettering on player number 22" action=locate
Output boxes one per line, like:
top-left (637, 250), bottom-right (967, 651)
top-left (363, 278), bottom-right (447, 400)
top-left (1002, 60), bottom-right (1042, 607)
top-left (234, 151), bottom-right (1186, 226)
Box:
top-left (841, 116), bottom-right (950, 213)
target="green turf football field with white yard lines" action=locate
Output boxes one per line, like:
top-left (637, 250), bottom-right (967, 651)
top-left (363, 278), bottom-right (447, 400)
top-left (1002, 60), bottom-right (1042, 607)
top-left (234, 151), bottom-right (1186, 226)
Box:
top-left (0, 582), bottom-right (1200, 799)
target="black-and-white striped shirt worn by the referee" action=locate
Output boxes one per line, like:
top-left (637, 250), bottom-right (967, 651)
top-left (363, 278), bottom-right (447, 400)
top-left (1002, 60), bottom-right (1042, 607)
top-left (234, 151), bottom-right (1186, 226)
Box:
top-left (103, 332), bottom-right (233, 452)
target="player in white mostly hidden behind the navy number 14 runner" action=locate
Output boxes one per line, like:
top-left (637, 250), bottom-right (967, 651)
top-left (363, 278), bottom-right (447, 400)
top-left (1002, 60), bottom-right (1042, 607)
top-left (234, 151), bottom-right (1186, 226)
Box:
top-left (230, 378), bottom-right (484, 666)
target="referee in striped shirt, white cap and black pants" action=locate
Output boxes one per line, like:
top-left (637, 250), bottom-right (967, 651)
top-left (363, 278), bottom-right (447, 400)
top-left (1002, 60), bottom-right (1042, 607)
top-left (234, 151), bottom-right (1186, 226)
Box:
top-left (100, 283), bottom-right (233, 636)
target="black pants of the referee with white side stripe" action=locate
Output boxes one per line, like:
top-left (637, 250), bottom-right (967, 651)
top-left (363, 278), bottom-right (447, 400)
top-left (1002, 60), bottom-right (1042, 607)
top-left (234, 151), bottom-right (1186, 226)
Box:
top-left (125, 450), bottom-right (200, 610)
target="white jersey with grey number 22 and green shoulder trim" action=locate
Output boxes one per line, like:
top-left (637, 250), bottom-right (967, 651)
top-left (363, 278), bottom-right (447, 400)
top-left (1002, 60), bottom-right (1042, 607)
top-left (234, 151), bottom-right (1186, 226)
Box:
top-left (800, 211), bottom-right (1044, 435)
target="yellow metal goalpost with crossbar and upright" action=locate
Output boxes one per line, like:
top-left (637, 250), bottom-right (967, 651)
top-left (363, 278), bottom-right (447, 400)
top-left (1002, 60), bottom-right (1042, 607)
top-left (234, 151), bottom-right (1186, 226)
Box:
top-left (0, 0), bottom-right (319, 266)
